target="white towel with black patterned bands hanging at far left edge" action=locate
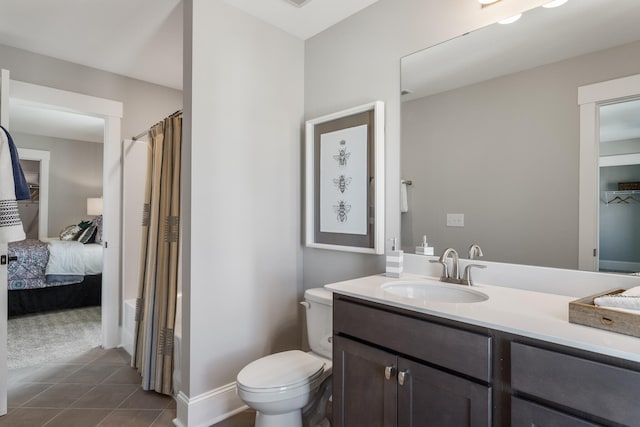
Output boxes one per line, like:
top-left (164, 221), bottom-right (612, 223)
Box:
top-left (0, 131), bottom-right (26, 243)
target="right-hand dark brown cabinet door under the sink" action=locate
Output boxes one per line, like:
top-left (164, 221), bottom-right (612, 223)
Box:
top-left (398, 358), bottom-right (491, 427)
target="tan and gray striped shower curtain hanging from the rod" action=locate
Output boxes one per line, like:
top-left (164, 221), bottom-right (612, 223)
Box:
top-left (131, 112), bottom-right (182, 395)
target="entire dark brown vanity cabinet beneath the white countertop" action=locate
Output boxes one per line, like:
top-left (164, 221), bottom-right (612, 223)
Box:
top-left (333, 293), bottom-right (640, 427)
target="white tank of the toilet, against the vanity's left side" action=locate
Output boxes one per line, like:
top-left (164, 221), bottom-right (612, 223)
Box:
top-left (303, 288), bottom-right (333, 359)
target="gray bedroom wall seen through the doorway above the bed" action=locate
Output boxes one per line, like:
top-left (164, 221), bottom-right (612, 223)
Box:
top-left (12, 133), bottom-right (103, 237)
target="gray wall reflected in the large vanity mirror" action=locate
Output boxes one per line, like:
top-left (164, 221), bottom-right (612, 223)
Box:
top-left (401, 43), bottom-right (640, 268)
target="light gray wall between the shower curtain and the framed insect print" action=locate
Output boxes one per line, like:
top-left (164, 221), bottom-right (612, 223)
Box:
top-left (178, 0), bottom-right (304, 408)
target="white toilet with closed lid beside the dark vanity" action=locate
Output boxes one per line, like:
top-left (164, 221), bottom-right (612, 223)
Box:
top-left (236, 288), bottom-right (333, 427)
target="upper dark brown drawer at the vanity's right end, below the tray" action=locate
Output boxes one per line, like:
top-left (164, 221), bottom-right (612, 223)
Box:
top-left (511, 342), bottom-right (640, 425)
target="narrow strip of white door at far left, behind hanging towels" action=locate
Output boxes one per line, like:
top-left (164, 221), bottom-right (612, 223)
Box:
top-left (0, 70), bottom-right (9, 415)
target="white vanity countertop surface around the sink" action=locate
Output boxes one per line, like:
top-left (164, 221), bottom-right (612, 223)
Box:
top-left (325, 273), bottom-right (640, 362)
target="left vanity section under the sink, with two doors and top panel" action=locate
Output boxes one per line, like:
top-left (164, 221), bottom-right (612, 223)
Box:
top-left (333, 294), bottom-right (492, 427)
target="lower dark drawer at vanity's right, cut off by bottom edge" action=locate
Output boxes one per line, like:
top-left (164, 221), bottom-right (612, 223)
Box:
top-left (511, 397), bottom-right (598, 427)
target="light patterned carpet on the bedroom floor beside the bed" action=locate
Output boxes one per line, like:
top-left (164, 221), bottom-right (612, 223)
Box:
top-left (7, 307), bottom-right (102, 369)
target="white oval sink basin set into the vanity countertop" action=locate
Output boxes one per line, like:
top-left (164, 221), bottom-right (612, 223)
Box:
top-left (381, 280), bottom-right (489, 303)
